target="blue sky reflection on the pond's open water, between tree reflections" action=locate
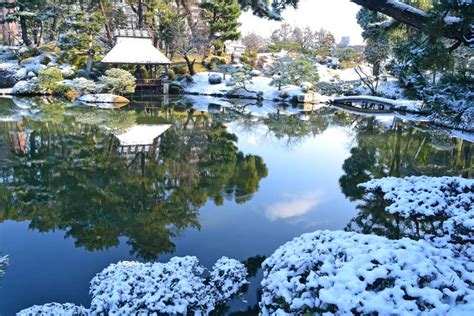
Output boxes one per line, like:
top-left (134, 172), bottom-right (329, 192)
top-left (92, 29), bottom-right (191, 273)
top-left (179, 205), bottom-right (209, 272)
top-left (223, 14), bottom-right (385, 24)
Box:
top-left (0, 118), bottom-right (355, 315)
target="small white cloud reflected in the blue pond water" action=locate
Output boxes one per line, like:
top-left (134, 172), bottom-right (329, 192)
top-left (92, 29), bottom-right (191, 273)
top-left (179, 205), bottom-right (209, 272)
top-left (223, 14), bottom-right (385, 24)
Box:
top-left (265, 193), bottom-right (321, 220)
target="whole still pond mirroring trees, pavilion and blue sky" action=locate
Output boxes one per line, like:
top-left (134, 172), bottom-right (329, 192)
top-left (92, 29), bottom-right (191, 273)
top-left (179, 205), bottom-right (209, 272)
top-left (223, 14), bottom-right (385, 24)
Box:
top-left (0, 98), bottom-right (474, 315)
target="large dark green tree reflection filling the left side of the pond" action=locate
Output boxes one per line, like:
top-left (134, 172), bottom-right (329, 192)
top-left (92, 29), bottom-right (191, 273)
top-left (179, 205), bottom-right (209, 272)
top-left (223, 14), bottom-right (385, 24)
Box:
top-left (0, 111), bottom-right (267, 259)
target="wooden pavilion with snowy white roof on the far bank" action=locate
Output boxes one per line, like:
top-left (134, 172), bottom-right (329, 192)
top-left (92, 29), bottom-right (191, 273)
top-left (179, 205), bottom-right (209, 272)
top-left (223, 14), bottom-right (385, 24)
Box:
top-left (102, 29), bottom-right (171, 94)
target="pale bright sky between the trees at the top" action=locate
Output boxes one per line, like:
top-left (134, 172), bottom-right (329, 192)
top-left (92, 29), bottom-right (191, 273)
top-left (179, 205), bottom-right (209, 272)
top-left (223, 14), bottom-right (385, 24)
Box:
top-left (241, 0), bottom-right (363, 44)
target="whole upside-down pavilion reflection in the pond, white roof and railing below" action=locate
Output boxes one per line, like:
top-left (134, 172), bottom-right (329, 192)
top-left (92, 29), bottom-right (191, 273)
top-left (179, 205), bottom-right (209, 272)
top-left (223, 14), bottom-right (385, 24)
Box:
top-left (115, 124), bottom-right (171, 160)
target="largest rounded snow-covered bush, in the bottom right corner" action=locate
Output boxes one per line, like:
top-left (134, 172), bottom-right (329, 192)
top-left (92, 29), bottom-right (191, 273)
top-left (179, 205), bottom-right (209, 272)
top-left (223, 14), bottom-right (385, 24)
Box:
top-left (260, 231), bottom-right (474, 315)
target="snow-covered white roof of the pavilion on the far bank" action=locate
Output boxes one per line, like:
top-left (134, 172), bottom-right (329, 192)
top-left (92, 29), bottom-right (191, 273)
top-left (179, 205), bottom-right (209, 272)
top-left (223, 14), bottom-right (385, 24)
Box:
top-left (102, 30), bottom-right (171, 65)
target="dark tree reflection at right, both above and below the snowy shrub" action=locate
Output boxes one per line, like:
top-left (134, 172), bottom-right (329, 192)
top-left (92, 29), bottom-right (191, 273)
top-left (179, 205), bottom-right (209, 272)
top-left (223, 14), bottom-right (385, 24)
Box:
top-left (339, 118), bottom-right (472, 239)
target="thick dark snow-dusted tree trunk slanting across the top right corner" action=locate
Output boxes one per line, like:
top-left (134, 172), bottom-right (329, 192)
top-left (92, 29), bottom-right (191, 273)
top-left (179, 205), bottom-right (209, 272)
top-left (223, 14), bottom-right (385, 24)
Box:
top-left (351, 0), bottom-right (474, 45)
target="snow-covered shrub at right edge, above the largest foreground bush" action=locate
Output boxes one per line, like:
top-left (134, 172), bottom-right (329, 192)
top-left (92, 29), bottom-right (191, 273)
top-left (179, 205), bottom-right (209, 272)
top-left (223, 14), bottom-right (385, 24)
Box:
top-left (360, 176), bottom-right (474, 247)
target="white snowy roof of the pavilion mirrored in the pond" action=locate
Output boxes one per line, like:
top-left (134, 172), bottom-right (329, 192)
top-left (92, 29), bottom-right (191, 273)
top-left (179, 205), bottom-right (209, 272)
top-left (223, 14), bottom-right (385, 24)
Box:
top-left (115, 124), bottom-right (171, 146)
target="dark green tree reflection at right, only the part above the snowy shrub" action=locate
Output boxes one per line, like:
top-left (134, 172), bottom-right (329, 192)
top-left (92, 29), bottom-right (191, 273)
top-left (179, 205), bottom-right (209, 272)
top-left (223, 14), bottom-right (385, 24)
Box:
top-left (339, 117), bottom-right (472, 200)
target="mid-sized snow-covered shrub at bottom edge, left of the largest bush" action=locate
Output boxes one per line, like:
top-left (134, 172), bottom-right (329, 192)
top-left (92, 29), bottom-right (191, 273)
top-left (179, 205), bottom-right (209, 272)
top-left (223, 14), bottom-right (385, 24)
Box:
top-left (90, 256), bottom-right (247, 315)
